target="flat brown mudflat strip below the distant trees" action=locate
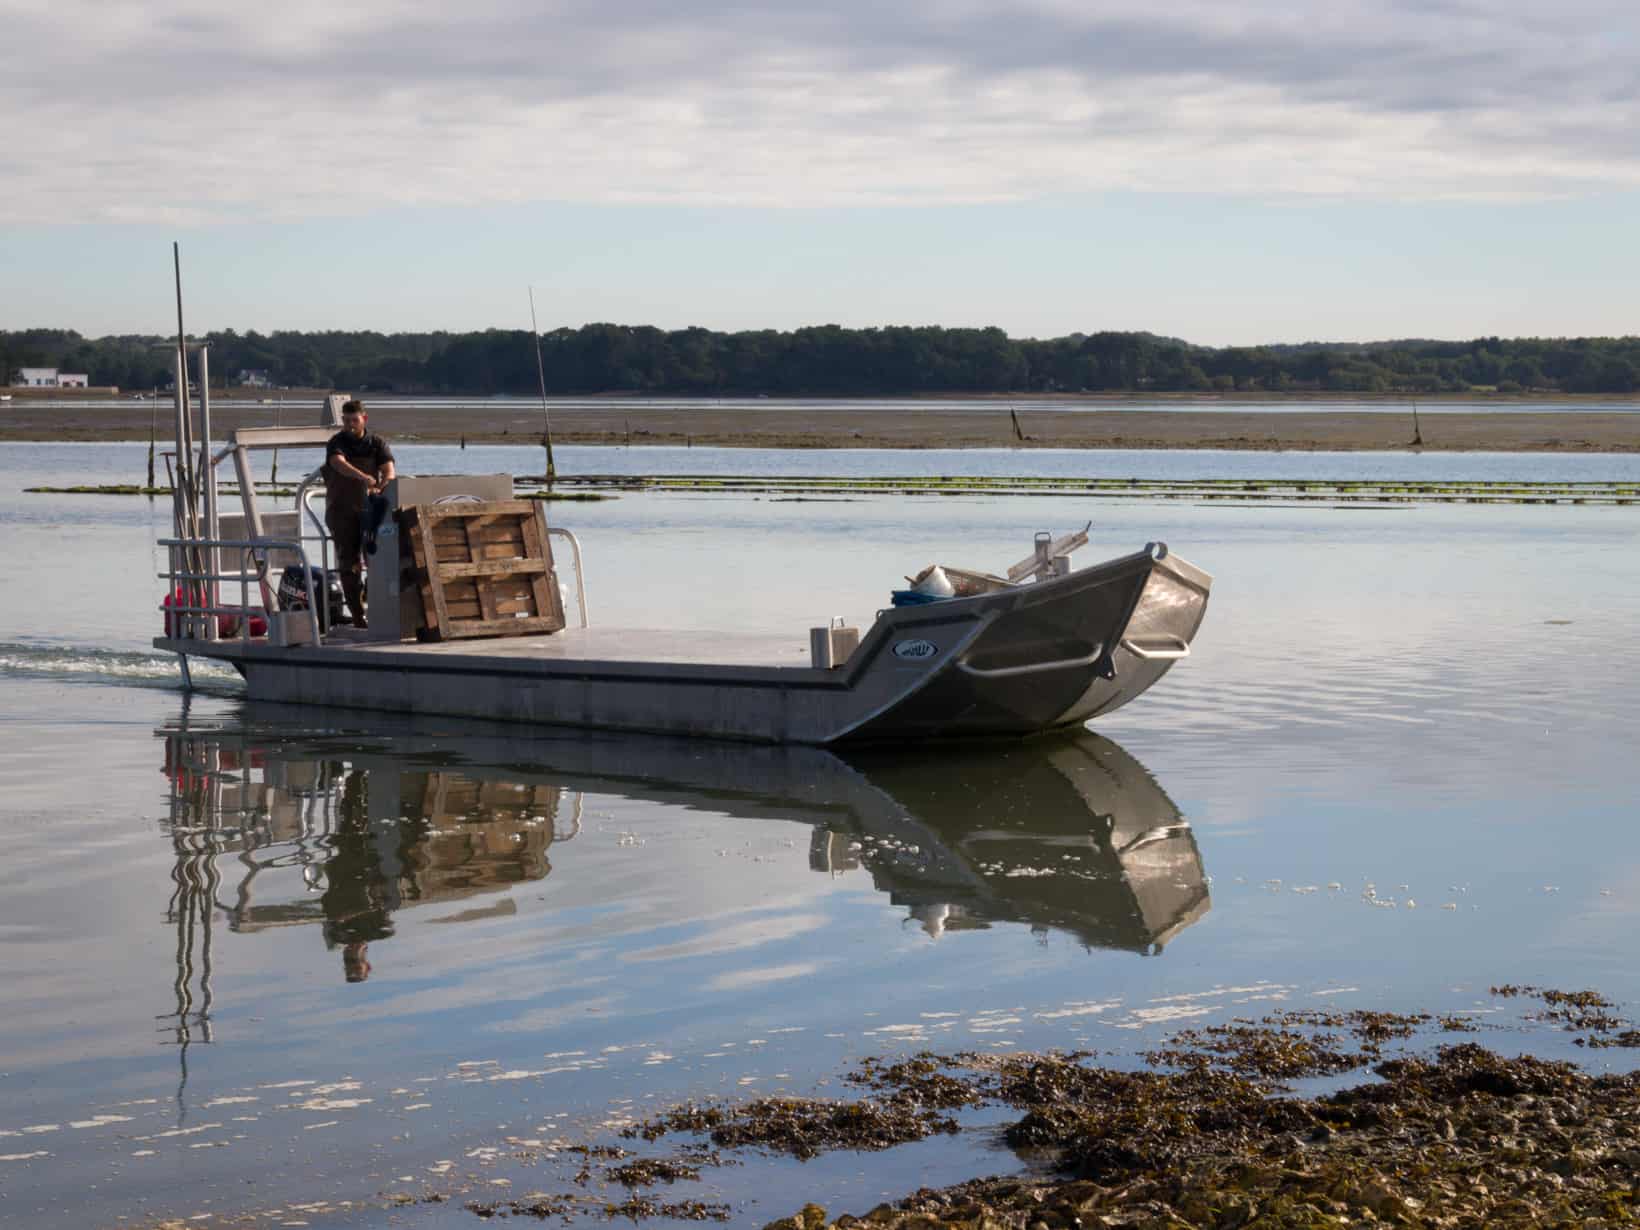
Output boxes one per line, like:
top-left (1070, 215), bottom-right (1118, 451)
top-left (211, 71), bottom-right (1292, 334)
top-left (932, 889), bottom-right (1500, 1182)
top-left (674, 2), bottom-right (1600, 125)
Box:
top-left (0, 402), bottom-right (1640, 453)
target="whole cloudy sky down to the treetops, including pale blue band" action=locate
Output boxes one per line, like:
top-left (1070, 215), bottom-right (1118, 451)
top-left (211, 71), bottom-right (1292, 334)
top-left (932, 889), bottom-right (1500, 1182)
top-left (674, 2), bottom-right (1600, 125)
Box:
top-left (0, 0), bottom-right (1640, 346)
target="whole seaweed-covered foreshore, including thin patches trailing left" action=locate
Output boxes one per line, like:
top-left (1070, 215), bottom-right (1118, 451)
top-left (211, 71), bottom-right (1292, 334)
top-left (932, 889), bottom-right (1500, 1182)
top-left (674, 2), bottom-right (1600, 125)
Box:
top-left (416, 986), bottom-right (1640, 1230)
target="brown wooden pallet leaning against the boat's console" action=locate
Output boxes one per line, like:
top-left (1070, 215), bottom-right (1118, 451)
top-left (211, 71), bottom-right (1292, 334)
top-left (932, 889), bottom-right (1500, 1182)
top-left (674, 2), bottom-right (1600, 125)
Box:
top-left (399, 500), bottom-right (564, 641)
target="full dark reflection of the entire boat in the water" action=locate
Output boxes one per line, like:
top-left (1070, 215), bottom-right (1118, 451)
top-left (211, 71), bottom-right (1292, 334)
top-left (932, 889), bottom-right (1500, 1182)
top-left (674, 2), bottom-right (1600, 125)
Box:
top-left (161, 704), bottom-right (1209, 1003)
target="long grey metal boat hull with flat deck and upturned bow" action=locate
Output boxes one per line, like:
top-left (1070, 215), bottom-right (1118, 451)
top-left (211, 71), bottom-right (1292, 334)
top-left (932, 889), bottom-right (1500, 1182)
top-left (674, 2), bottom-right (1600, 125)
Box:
top-left (156, 546), bottom-right (1210, 745)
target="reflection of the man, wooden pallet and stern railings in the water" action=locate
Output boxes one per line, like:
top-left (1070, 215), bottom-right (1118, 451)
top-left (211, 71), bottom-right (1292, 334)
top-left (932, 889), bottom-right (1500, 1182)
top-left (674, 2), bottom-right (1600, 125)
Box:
top-left (162, 725), bottom-right (582, 994)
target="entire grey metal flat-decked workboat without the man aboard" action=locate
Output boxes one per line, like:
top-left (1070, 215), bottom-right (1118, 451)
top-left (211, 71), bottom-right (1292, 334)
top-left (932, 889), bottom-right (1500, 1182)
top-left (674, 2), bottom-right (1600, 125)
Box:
top-left (154, 390), bottom-right (1212, 745)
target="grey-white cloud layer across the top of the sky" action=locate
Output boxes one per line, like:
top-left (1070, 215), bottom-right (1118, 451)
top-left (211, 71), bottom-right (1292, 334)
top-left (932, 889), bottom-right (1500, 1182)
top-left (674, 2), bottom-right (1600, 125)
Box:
top-left (9, 0), bottom-right (1640, 223)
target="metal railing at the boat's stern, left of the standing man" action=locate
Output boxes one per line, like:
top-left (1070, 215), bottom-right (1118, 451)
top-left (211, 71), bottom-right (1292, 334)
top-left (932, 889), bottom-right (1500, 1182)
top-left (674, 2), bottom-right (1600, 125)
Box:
top-left (157, 538), bottom-right (328, 656)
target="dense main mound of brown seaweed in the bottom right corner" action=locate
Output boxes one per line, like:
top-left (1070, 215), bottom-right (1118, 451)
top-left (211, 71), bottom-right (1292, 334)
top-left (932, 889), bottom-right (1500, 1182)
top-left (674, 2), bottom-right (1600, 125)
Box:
top-left (760, 1032), bottom-right (1640, 1230)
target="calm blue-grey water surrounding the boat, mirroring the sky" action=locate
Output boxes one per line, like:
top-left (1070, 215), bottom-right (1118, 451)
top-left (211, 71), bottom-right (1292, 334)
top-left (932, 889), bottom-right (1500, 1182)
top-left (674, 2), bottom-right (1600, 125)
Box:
top-left (0, 446), bottom-right (1640, 1227)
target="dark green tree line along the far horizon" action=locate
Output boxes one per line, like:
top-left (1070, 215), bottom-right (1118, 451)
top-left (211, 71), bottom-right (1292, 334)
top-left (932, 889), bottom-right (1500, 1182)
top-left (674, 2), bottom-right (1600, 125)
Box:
top-left (9, 325), bottom-right (1640, 397)
